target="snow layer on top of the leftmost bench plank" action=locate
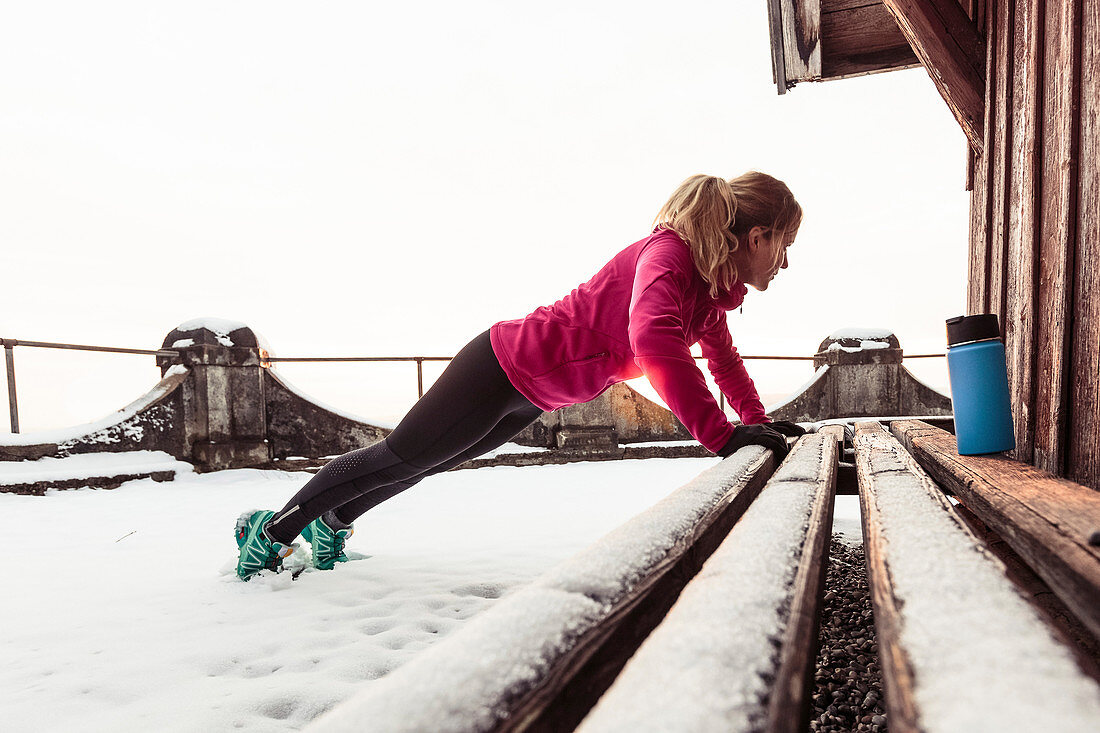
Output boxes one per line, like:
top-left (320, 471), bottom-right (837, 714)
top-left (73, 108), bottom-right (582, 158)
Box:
top-left (310, 446), bottom-right (766, 733)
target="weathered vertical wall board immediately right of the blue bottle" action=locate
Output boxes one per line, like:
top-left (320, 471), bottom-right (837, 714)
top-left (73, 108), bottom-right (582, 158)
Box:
top-left (1003, 0), bottom-right (1044, 462)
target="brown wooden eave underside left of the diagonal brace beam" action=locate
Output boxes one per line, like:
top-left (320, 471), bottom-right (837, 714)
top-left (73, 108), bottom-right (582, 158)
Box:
top-left (821, 0), bottom-right (921, 79)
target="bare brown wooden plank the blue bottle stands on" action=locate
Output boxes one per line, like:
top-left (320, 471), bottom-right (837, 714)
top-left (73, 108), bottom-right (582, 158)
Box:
top-left (891, 420), bottom-right (1100, 637)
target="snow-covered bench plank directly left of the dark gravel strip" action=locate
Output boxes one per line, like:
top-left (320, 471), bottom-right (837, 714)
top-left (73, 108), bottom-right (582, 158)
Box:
top-left (578, 427), bottom-right (843, 733)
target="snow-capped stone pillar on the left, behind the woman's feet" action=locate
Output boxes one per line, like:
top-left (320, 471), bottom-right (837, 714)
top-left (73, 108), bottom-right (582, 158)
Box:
top-left (157, 318), bottom-right (271, 470)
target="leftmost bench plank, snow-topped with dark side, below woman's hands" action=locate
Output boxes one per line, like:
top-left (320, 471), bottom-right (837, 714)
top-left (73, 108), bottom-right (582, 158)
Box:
top-left (308, 446), bottom-right (774, 733)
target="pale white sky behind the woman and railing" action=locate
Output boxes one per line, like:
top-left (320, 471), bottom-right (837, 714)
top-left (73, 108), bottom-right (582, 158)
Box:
top-left (0, 0), bottom-right (969, 431)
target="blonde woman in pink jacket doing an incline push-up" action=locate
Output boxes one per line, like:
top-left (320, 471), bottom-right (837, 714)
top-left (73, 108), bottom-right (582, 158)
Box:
top-left (237, 172), bottom-right (802, 580)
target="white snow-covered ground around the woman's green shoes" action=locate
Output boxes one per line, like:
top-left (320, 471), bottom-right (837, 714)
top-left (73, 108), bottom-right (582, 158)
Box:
top-left (0, 459), bottom-right (859, 731)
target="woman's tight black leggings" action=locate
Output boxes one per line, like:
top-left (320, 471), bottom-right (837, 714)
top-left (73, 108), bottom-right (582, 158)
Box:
top-left (267, 331), bottom-right (542, 544)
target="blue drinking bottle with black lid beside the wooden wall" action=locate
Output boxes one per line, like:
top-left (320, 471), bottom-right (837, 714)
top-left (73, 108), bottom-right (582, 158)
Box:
top-left (947, 314), bottom-right (1016, 456)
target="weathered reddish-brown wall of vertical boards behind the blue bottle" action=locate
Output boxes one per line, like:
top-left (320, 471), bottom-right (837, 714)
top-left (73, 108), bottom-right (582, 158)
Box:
top-left (967, 0), bottom-right (1100, 489)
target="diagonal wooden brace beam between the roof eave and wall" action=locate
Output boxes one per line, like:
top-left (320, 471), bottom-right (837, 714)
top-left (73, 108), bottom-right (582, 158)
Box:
top-left (882, 0), bottom-right (986, 151)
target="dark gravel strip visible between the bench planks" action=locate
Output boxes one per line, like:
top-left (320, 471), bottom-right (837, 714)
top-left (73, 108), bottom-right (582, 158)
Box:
top-left (810, 535), bottom-right (889, 731)
